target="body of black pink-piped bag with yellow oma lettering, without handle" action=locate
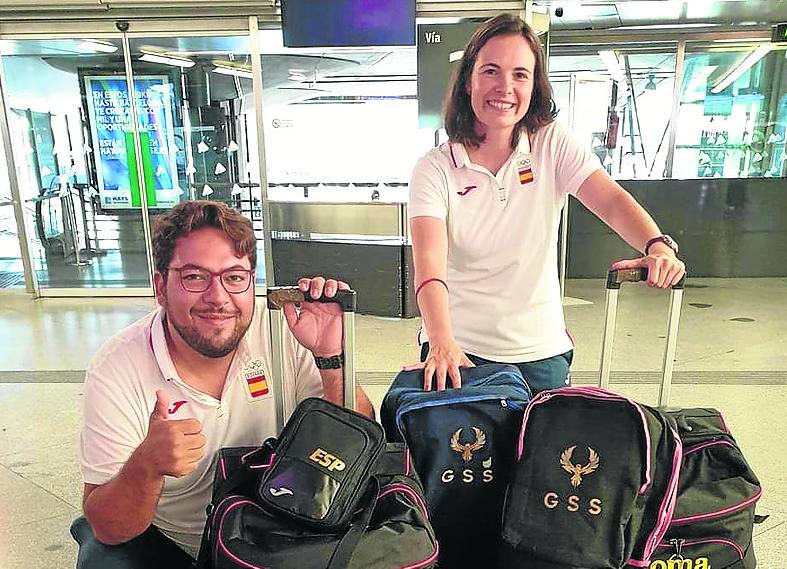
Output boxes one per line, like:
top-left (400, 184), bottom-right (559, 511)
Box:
top-left (650, 409), bottom-right (762, 569)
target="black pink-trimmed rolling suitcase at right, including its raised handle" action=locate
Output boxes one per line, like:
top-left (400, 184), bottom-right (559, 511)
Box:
top-left (599, 269), bottom-right (762, 569)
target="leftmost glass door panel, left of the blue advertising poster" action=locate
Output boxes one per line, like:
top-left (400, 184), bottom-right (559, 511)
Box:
top-left (2, 37), bottom-right (150, 290)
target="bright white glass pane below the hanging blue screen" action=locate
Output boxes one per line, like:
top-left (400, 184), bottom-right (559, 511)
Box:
top-left (260, 30), bottom-right (424, 202)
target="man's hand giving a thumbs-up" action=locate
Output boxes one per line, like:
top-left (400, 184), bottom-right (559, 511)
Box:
top-left (135, 389), bottom-right (206, 478)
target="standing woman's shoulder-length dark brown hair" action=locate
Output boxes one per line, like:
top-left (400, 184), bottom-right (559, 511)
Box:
top-left (445, 14), bottom-right (557, 148)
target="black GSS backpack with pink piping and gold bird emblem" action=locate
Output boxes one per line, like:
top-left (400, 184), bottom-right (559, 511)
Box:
top-left (498, 386), bottom-right (681, 569)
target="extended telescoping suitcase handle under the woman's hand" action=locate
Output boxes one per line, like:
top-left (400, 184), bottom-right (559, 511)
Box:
top-left (598, 268), bottom-right (686, 407)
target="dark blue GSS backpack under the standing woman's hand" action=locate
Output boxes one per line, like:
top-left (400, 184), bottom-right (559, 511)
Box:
top-left (380, 364), bottom-right (530, 569)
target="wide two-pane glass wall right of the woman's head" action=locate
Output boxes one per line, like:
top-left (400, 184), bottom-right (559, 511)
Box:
top-left (549, 38), bottom-right (787, 179)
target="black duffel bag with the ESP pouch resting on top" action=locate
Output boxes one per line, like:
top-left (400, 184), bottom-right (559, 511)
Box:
top-left (197, 399), bottom-right (438, 569)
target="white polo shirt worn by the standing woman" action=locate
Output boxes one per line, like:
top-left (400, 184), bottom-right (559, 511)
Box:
top-left (408, 121), bottom-right (601, 362)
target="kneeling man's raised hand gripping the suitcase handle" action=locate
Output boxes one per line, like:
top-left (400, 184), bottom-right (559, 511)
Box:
top-left (284, 277), bottom-right (350, 357)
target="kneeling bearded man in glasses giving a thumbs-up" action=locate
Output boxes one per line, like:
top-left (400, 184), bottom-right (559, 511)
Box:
top-left (71, 201), bottom-right (373, 569)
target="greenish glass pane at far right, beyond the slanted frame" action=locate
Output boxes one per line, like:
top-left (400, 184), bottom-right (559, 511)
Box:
top-left (673, 43), bottom-right (787, 178)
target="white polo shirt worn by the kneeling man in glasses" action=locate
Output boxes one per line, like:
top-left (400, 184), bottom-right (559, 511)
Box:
top-left (78, 301), bottom-right (322, 556)
